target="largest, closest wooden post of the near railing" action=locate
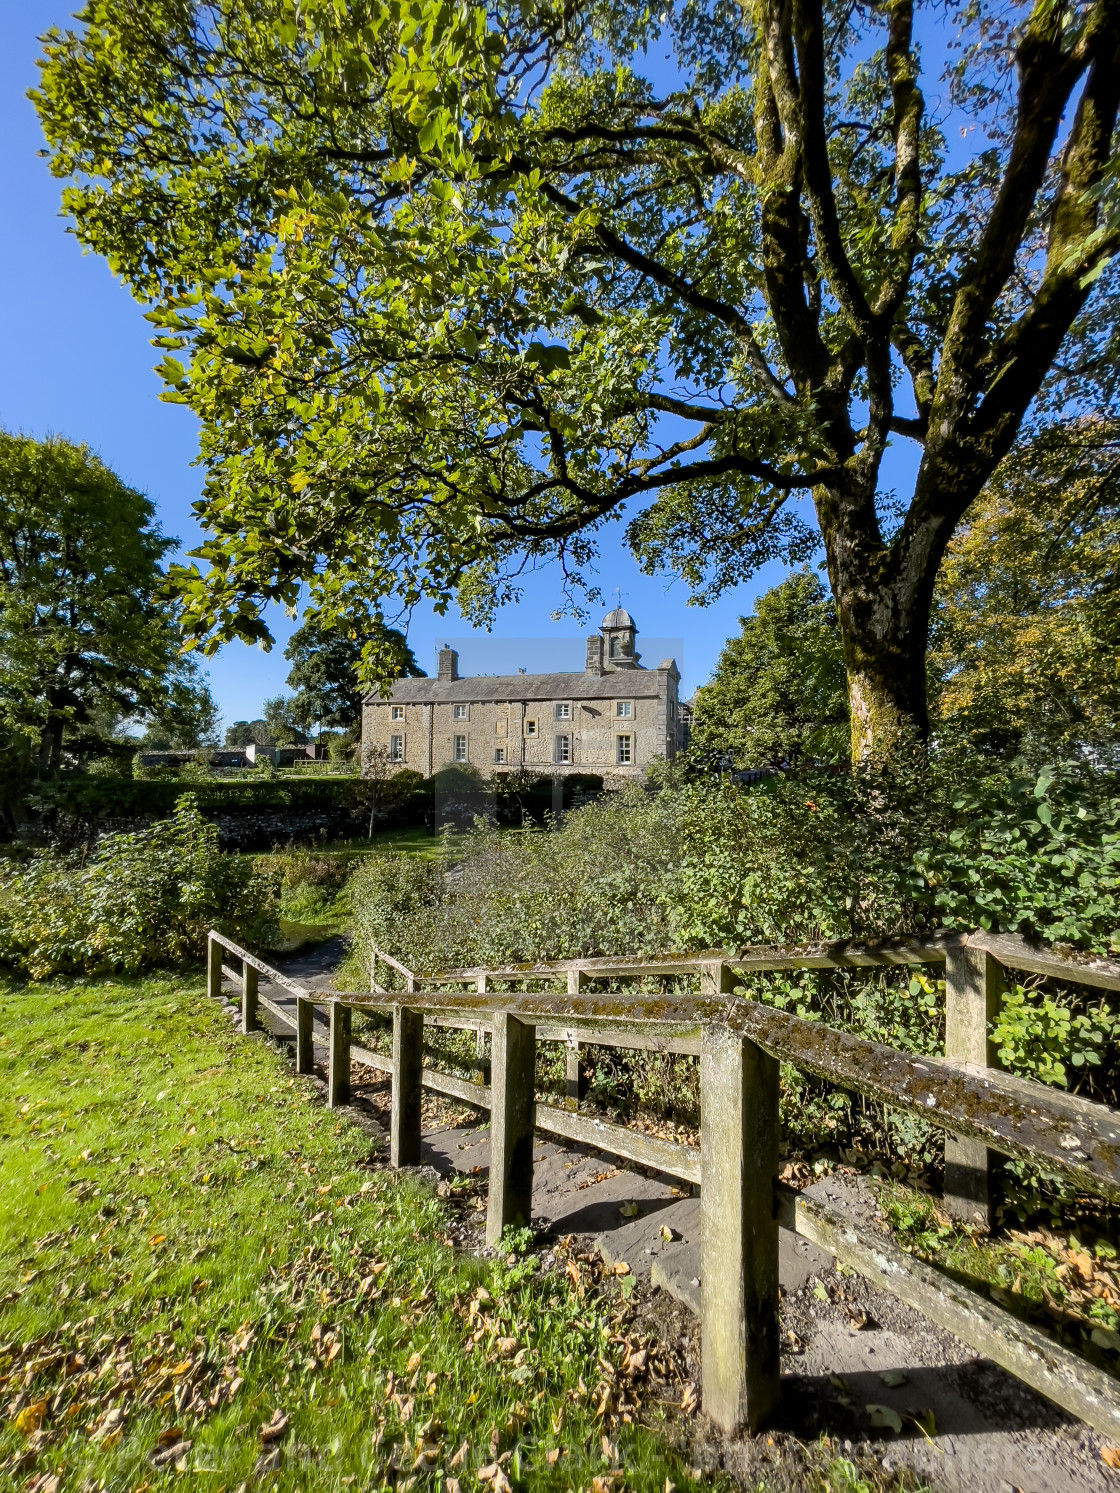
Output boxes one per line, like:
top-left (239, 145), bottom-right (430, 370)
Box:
top-left (700, 1026), bottom-right (780, 1432)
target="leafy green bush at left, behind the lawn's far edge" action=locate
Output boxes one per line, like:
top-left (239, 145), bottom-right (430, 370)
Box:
top-left (0, 796), bottom-right (276, 979)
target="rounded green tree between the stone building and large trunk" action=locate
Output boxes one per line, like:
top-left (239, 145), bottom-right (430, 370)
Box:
top-left (691, 570), bottom-right (850, 767)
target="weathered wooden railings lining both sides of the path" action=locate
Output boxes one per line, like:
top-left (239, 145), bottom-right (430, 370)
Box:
top-left (209, 933), bottom-right (1120, 1441)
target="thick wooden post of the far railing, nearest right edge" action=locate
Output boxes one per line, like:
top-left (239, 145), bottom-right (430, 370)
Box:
top-left (944, 947), bottom-right (1004, 1229)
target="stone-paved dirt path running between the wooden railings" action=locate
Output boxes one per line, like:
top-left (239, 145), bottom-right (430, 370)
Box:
top-left (225, 941), bottom-right (1120, 1493)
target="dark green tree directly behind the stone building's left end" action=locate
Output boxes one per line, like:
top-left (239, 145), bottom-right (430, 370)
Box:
top-left (284, 615), bottom-right (424, 730)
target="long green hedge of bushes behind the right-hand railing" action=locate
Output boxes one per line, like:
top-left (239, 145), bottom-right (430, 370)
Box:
top-left (348, 761), bottom-right (1120, 1163)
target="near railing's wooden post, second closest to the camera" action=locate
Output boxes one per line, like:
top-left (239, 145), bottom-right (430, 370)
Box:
top-left (487, 1011), bottom-right (536, 1244)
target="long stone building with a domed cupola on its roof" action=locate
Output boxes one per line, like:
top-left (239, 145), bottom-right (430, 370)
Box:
top-left (361, 608), bottom-right (684, 781)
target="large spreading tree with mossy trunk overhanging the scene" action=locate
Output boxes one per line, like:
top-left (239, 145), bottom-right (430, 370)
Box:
top-left (37, 0), bottom-right (1120, 757)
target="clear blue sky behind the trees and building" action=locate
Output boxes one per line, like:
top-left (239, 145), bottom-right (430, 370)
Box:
top-left (0, 0), bottom-right (937, 724)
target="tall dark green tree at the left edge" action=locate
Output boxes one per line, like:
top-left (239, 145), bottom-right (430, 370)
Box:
top-left (0, 433), bottom-right (209, 773)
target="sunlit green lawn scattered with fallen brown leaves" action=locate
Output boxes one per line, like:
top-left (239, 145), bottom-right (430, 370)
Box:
top-left (0, 976), bottom-right (704, 1493)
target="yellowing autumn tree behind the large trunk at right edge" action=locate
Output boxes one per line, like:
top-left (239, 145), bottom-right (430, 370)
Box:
top-left (930, 421), bottom-right (1120, 761)
